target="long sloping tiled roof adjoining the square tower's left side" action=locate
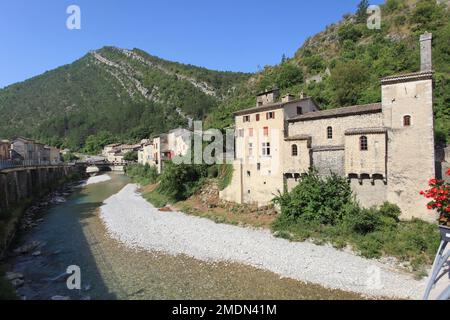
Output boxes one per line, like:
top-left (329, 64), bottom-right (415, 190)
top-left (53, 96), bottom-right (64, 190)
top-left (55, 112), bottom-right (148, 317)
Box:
top-left (288, 103), bottom-right (381, 122)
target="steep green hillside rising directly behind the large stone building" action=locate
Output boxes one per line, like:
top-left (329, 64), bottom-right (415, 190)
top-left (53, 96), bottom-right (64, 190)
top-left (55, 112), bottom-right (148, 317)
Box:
top-left (208, 0), bottom-right (450, 142)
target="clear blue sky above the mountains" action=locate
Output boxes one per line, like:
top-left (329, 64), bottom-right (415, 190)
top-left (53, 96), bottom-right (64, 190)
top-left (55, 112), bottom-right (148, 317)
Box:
top-left (0, 0), bottom-right (383, 88)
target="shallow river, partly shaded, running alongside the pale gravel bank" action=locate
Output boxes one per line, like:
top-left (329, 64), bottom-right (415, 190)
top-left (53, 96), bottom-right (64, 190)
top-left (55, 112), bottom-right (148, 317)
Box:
top-left (7, 173), bottom-right (360, 299)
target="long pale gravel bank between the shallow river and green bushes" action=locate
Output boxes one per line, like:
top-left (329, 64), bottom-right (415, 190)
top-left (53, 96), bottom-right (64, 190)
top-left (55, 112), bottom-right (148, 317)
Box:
top-left (101, 184), bottom-right (425, 298)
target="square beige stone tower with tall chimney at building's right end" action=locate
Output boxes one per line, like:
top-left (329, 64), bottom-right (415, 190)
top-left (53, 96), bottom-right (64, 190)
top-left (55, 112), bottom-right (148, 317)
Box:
top-left (381, 33), bottom-right (435, 221)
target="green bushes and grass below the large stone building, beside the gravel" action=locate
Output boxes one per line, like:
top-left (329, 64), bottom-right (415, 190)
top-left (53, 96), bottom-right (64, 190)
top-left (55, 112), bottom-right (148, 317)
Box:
top-left (272, 170), bottom-right (440, 274)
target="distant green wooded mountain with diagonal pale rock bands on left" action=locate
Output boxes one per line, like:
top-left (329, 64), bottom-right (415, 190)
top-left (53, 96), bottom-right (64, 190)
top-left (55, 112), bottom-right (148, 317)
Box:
top-left (0, 47), bottom-right (250, 151)
